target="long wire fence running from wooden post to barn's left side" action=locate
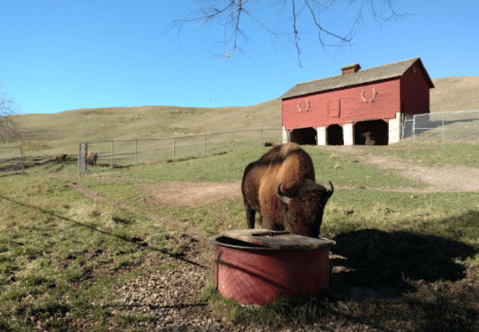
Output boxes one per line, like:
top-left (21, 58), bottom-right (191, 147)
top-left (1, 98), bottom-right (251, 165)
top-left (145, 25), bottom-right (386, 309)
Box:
top-left (78, 129), bottom-right (282, 176)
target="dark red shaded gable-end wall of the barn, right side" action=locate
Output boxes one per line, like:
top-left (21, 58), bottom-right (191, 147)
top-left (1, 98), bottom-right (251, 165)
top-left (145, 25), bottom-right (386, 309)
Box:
top-left (401, 61), bottom-right (429, 114)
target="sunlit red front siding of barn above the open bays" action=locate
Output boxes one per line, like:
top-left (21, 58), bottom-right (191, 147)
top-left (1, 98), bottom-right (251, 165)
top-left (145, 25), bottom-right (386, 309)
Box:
top-left (282, 78), bottom-right (402, 131)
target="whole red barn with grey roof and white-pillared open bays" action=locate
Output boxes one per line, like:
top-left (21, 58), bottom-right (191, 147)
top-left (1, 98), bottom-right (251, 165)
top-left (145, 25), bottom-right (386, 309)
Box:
top-left (281, 58), bottom-right (434, 145)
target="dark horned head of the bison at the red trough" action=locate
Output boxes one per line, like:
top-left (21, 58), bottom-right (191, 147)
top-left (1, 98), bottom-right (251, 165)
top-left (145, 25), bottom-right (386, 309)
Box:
top-left (276, 180), bottom-right (334, 237)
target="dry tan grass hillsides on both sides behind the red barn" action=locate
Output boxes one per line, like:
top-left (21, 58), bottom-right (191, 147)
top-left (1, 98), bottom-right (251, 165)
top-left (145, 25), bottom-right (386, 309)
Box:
top-left (3, 76), bottom-right (479, 155)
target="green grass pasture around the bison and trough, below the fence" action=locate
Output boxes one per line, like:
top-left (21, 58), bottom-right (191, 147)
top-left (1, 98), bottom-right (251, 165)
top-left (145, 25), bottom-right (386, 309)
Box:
top-left (0, 143), bottom-right (479, 331)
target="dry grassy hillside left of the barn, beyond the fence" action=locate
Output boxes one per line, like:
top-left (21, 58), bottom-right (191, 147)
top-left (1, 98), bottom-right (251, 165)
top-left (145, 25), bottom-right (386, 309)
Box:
top-left (0, 99), bottom-right (281, 158)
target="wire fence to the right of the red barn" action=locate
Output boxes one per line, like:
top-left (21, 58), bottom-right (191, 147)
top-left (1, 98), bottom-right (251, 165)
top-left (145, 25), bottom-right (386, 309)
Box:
top-left (402, 111), bottom-right (479, 141)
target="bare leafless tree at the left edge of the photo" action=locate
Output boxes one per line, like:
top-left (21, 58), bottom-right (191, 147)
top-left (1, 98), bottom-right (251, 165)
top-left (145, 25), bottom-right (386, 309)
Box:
top-left (0, 84), bottom-right (21, 142)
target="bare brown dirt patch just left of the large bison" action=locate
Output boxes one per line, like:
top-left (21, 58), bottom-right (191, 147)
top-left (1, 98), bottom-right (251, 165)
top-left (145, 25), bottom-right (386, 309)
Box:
top-left (142, 181), bottom-right (243, 207)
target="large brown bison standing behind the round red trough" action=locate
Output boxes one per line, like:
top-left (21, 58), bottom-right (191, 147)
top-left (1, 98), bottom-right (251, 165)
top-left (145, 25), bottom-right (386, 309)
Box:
top-left (241, 143), bottom-right (334, 237)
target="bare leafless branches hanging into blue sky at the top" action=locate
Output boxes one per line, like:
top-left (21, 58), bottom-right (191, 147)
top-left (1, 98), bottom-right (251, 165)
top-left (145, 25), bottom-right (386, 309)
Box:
top-left (165, 0), bottom-right (404, 67)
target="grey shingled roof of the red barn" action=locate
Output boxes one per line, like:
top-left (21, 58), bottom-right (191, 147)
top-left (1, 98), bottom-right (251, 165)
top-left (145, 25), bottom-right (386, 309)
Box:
top-left (281, 57), bottom-right (434, 99)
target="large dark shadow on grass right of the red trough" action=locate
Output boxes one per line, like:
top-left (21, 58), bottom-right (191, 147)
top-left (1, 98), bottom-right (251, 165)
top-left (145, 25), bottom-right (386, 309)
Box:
top-left (330, 215), bottom-right (479, 300)
